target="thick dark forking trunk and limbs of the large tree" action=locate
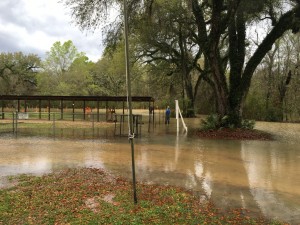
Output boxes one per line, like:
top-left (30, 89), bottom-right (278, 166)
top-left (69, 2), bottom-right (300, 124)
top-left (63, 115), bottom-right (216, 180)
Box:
top-left (192, 0), bottom-right (300, 127)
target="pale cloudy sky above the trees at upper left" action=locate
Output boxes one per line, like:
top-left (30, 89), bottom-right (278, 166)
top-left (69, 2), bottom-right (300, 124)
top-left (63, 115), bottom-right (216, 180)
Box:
top-left (0, 0), bottom-right (103, 61)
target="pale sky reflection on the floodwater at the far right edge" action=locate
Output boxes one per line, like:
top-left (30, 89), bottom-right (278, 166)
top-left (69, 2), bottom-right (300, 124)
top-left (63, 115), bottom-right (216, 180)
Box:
top-left (241, 142), bottom-right (300, 224)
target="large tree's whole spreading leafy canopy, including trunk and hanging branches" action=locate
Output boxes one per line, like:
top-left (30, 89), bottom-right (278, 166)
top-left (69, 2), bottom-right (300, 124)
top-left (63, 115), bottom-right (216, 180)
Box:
top-left (63, 0), bottom-right (300, 127)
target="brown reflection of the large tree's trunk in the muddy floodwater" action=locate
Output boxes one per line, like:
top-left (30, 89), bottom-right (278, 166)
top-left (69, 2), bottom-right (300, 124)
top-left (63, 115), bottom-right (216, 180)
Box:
top-left (190, 141), bottom-right (260, 216)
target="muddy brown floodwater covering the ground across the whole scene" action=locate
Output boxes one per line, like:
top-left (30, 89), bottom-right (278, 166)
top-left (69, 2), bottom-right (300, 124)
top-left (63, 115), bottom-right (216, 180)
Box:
top-left (0, 119), bottom-right (300, 224)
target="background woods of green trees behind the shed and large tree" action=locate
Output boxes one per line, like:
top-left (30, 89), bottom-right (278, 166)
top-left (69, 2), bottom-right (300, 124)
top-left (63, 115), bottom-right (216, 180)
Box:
top-left (0, 1), bottom-right (300, 121)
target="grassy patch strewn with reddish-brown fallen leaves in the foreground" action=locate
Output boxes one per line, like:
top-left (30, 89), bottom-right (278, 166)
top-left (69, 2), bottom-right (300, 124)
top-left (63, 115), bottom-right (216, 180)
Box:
top-left (0, 168), bottom-right (281, 224)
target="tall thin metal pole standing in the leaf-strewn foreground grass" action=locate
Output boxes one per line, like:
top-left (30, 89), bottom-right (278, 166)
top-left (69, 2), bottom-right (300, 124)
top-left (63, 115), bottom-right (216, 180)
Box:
top-left (124, 0), bottom-right (137, 204)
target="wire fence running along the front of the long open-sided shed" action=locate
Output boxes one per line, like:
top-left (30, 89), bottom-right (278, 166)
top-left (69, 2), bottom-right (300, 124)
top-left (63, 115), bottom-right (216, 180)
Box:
top-left (0, 110), bottom-right (169, 138)
